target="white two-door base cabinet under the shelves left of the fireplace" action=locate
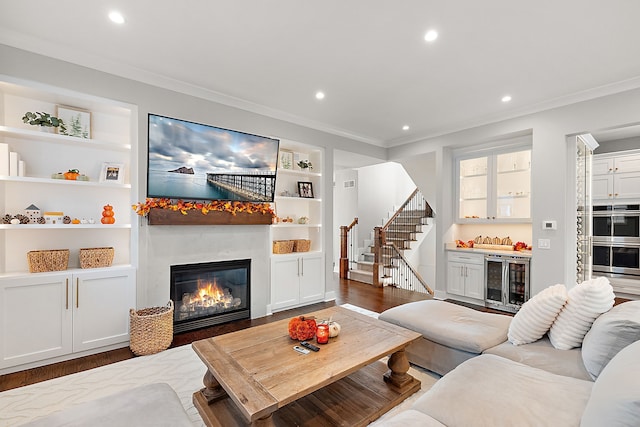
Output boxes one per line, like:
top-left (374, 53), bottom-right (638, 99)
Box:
top-left (0, 267), bottom-right (136, 372)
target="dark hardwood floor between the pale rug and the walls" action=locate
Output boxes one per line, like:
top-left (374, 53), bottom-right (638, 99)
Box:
top-left (0, 280), bottom-right (431, 391)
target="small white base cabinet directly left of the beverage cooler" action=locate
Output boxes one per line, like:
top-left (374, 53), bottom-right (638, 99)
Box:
top-left (447, 252), bottom-right (484, 300)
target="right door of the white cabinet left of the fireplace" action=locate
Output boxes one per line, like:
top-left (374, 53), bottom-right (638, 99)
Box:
top-left (73, 269), bottom-right (136, 351)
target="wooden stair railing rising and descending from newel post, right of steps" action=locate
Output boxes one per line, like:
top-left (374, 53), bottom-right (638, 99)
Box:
top-left (373, 188), bottom-right (433, 295)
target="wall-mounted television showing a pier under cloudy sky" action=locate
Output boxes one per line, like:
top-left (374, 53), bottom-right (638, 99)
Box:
top-left (147, 114), bottom-right (280, 202)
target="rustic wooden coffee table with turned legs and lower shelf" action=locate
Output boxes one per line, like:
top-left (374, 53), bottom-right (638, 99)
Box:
top-left (192, 306), bottom-right (421, 427)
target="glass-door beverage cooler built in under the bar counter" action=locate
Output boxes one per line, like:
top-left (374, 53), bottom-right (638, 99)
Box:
top-left (484, 255), bottom-right (530, 313)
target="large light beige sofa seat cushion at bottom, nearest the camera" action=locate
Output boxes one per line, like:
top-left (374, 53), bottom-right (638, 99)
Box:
top-left (413, 354), bottom-right (592, 427)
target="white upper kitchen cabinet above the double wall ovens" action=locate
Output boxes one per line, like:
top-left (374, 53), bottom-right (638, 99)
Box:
top-left (591, 154), bottom-right (640, 203)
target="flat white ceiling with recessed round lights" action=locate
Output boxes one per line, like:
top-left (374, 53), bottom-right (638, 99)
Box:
top-left (0, 0), bottom-right (640, 146)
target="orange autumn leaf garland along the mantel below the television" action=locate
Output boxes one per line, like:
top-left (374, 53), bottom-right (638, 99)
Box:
top-left (132, 198), bottom-right (274, 217)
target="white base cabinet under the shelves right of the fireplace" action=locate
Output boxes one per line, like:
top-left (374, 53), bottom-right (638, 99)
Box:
top-left (271, 253), bottom-right (325, 311)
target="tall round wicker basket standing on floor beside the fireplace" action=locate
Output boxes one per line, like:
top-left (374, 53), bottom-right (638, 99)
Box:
top-left (129, 301), bottom-right (173, 356)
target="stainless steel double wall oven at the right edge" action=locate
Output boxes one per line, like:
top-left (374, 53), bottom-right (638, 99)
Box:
top-left (592, 204), bottom-right (640, 278)
